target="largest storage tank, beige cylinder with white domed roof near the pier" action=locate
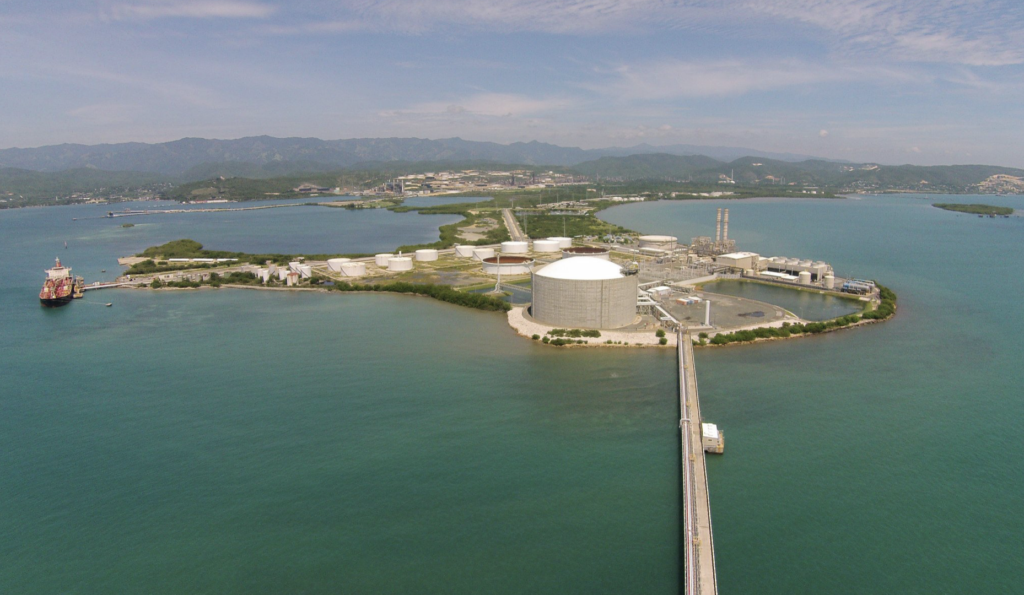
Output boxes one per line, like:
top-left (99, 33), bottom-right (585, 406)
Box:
top-left (530, 256), bottom-right (638, 329)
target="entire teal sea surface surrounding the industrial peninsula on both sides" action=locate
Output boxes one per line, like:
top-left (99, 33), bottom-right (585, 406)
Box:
top-left (0, 192), bottom-right (1024, 594)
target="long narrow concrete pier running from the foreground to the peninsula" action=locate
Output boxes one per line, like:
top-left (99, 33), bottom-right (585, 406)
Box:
top-left (676, 330), bottom-right (718, 595)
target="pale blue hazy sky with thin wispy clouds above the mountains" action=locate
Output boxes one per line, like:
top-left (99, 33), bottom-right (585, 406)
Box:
top-left (0, 0), bottom-right (1024, 167)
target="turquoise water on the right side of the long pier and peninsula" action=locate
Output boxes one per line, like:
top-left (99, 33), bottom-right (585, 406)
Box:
top-left (603, 196), bottom-right (1024, 594)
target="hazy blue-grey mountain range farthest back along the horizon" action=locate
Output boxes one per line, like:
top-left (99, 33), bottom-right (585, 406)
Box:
top-left (0, 136), bottom-right (835, 180)
